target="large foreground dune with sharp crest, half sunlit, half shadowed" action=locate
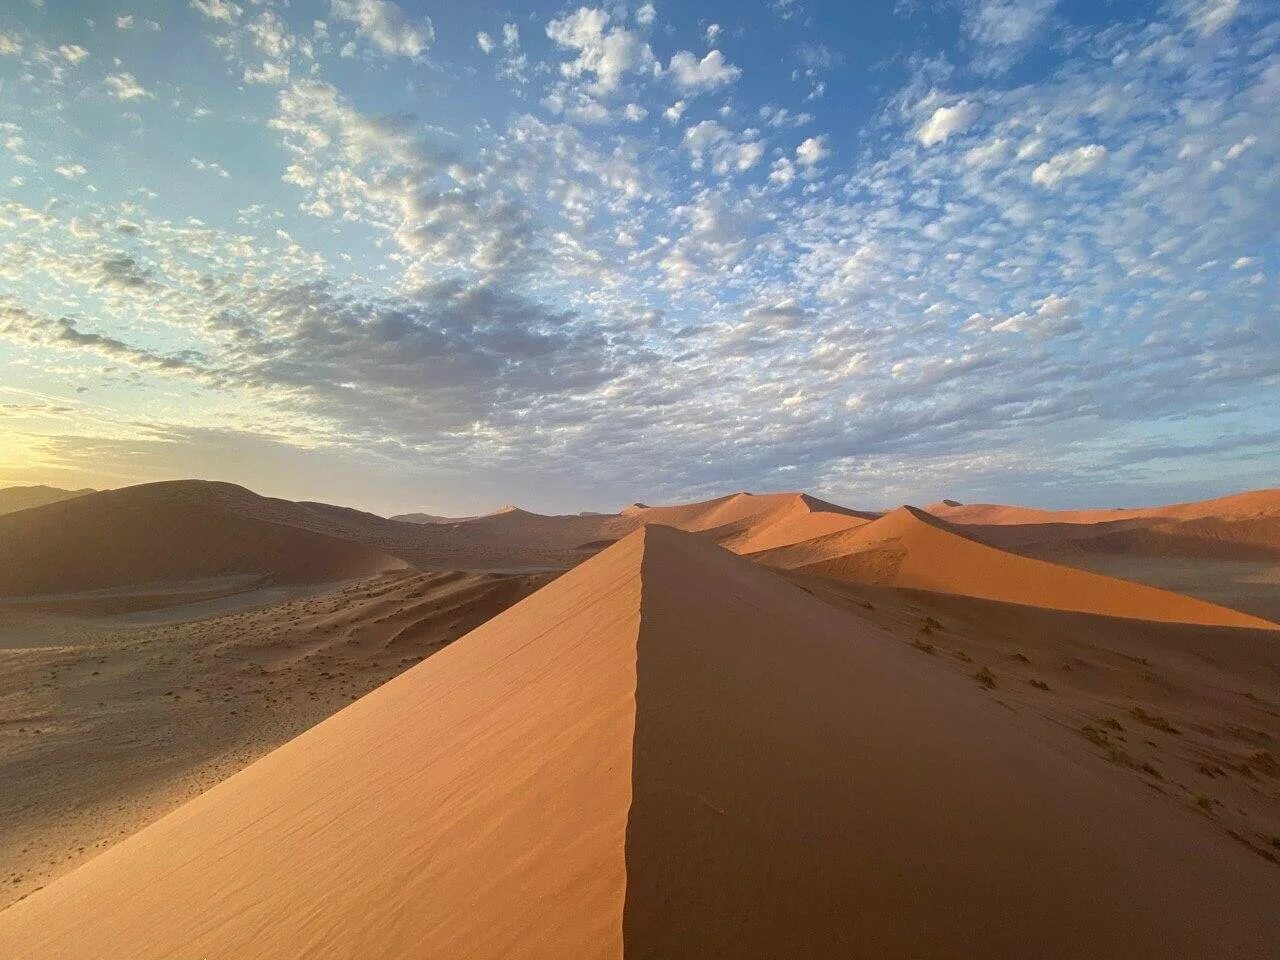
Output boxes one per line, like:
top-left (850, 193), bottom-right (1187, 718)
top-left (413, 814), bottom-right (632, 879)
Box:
top-left (0, 526), bottom-right (1280, 960)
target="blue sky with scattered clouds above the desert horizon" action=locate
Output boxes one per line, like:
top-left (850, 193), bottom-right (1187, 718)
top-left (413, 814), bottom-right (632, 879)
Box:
top-left (0, 0), bottom-right (1280, 515)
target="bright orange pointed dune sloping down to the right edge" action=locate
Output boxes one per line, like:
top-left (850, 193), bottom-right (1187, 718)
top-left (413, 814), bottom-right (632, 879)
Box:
top-left (758, 507), bottom-right (1280, 630)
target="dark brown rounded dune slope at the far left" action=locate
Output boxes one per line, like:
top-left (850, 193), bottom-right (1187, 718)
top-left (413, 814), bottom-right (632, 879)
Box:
top-left (0, 484), bottom-right (404, 596)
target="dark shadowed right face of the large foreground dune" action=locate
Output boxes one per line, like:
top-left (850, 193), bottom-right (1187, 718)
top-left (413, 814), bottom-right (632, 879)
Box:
top-left (625, 529), bottom-right (1280, 957)
